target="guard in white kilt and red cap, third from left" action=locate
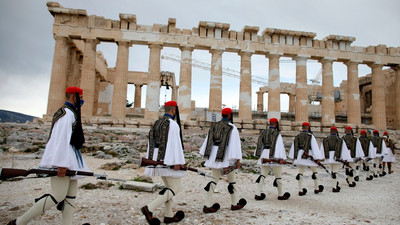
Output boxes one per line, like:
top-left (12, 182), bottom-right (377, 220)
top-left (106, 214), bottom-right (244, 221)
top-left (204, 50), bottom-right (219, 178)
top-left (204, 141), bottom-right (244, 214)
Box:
top-left (200, 108), bottom-right (247, 213)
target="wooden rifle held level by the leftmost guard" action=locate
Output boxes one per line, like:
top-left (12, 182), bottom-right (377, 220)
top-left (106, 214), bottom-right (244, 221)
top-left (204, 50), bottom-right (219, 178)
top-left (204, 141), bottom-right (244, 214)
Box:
top-left (0, 168), bottom-right (125, 182)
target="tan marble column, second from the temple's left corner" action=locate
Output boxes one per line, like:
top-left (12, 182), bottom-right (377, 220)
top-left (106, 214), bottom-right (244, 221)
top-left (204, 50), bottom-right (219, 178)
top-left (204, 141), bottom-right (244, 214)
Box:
top-left (81, 39), bottom-right (99, 117)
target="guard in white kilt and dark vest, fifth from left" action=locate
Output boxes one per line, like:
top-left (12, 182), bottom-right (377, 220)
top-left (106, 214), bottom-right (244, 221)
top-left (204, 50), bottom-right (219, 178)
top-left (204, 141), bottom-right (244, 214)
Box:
top-left (289, 122), bottom-right (324, 196)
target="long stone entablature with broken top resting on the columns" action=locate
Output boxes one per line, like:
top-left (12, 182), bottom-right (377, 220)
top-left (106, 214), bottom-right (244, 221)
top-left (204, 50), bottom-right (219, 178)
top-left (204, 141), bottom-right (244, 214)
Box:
top-left (48, 2), bottom-right (400, 65)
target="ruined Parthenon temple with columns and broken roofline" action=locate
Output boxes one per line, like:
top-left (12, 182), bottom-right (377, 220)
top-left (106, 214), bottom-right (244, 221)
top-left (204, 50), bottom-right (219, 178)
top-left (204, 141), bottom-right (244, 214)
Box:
top-left (45, 2), bottom-right (400, 130)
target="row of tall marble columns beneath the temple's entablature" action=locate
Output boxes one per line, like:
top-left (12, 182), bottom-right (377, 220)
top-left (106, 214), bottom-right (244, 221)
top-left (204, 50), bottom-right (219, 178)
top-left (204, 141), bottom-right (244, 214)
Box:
top-left (47, 37), bottom-right (400, 129)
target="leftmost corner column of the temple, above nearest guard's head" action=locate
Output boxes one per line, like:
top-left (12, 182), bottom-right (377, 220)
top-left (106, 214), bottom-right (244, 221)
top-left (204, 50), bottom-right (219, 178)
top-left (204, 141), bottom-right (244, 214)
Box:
top-left (46, 36), bottom-right (70, 116)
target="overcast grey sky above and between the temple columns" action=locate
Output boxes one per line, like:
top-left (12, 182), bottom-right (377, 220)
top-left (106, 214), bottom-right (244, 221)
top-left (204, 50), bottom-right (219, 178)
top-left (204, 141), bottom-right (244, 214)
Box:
top-left (0, 0), bottom-right (400, 117)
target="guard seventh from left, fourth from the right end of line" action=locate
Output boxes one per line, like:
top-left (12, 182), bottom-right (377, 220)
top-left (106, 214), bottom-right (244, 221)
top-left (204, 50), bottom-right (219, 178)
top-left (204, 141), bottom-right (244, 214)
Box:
top-left (342, 126), bottom-right (365, 187)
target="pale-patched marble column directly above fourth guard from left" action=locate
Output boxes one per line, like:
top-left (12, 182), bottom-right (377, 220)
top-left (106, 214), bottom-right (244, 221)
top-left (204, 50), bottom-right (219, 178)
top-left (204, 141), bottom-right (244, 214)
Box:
top-left (267, 54), bottom-right (281, 120)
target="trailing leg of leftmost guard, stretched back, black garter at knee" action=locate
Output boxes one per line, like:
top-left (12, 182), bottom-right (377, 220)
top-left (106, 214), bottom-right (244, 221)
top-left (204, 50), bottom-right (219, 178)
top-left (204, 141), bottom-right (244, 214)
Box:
top-left (17, 177), bottom-right (70, 225)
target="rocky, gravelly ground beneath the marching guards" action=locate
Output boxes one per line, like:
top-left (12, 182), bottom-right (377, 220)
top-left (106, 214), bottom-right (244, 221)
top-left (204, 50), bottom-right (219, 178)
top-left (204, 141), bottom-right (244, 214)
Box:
top-left (0, 124), bottom-right (400, 224)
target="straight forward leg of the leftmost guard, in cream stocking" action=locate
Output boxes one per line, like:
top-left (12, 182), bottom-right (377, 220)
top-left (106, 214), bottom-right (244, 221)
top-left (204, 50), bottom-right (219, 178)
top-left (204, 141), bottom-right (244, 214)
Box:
top-left (57, 180), bottom-right (78, 225)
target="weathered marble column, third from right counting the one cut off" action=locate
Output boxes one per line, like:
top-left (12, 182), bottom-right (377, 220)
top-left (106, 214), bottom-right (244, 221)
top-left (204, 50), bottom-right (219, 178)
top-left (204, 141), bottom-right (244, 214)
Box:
top-left (345, 61), bottom-right (361, 124)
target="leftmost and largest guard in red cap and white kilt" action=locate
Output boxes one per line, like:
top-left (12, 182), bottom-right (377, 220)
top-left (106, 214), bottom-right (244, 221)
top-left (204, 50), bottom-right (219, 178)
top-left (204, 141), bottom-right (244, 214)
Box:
top-left (8, 87), bottom-right (89, 225)
